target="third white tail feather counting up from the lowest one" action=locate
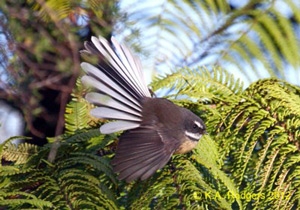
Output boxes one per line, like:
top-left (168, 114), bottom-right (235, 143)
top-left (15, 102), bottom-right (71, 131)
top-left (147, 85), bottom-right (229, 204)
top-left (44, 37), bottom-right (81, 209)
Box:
top-left (85, 92), bottom-right (142, 117)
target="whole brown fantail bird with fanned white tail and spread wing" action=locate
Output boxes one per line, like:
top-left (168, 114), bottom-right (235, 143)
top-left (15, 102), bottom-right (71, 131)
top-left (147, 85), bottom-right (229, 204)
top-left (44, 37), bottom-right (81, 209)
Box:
top-left (81, 37), bottom-right (206, 182)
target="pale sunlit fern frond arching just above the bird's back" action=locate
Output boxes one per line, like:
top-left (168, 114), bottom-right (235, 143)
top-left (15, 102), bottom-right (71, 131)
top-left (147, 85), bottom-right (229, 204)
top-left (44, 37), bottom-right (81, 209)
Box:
top-left (151, 67), bottom-right (243, 101)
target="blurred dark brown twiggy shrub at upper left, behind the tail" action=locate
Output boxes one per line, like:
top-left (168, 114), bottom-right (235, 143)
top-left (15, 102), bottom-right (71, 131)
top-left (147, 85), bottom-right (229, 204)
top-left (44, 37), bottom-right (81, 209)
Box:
top-left (0, 0), bottom-right (118, 142)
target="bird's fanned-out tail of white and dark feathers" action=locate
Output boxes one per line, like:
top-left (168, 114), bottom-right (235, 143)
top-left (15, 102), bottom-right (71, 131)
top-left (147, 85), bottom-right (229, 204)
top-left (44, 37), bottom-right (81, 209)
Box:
top-left (81, 37), bottom-right (151, 134)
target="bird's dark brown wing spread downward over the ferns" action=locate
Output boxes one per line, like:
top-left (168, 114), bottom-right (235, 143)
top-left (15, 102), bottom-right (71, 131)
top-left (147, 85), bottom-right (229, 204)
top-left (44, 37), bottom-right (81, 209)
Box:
top-left (112, 127), bottom-right (178, 182)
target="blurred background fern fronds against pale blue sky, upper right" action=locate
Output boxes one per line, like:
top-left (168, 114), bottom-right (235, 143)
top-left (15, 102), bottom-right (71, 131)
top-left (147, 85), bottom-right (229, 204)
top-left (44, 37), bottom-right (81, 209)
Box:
top-left (123, 0), bottom-right (300, 82)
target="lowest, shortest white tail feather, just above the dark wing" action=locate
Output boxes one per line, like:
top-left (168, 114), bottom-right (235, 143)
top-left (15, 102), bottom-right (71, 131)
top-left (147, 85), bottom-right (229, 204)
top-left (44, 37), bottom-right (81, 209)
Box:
top-left (100, 120), bottom-right (140, 134)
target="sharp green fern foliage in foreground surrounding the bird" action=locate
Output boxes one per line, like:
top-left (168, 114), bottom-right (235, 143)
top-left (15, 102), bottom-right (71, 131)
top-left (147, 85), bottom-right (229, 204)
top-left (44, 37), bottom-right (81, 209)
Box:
top-left (0, 68), bottom-right (300, 209)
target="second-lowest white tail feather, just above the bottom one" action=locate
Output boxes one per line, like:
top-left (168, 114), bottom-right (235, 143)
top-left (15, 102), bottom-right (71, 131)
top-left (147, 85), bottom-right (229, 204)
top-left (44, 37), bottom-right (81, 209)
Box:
top-left (90, 107), bottom-right (142, 122)
